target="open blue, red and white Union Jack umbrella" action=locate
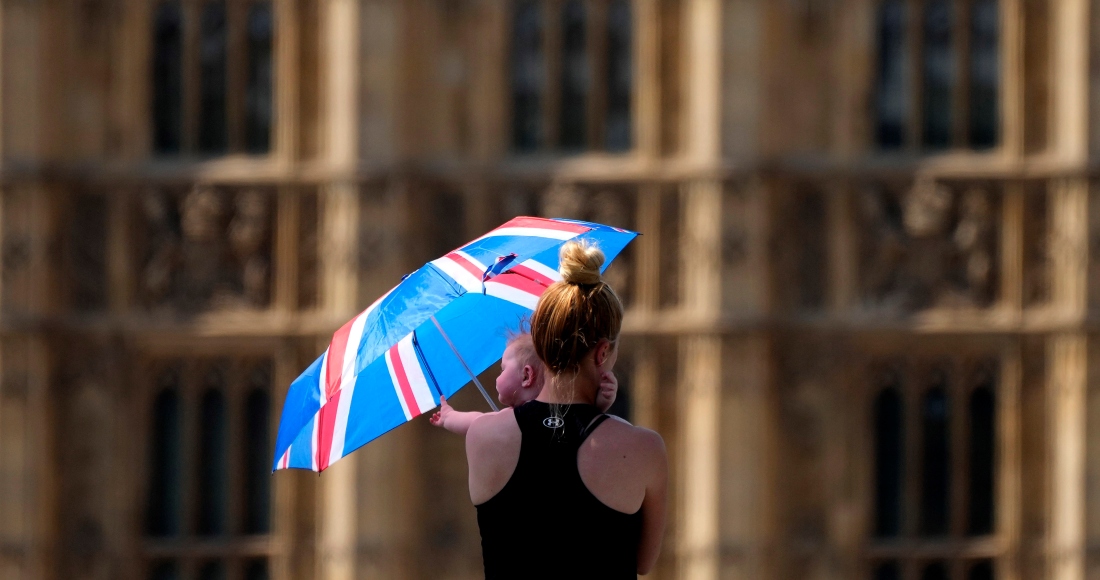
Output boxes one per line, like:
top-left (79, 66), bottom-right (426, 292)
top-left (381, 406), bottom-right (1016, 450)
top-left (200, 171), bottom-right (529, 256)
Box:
top-left (274, 217), bottom-right (637, 472)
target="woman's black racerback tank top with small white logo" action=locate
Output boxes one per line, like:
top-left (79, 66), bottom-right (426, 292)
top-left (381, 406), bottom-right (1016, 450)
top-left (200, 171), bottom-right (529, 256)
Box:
top-left (477, 401), bottom-right (641, 580)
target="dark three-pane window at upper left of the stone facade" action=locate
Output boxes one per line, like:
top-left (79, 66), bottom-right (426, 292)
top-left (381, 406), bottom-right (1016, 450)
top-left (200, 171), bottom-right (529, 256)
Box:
top-left (150, 0), bottom-right (274, 156)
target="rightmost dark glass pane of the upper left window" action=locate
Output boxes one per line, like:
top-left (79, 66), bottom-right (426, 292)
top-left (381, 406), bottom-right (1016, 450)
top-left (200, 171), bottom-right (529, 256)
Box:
top-left (244, 2), bottom-right (275, 153)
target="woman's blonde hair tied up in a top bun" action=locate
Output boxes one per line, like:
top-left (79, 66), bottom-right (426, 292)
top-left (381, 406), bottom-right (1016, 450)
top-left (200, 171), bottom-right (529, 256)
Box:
top-left (531, 241), bottom-right (623, 375)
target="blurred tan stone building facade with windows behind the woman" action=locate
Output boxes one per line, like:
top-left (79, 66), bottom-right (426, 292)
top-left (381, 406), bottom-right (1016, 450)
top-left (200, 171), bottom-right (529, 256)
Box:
top-left (0, 0), bottom-right (1100, 580)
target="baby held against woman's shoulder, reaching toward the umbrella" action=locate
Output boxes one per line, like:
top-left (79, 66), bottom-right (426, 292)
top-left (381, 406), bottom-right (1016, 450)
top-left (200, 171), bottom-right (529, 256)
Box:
top-left (430, 332), bottom-right (618, 435)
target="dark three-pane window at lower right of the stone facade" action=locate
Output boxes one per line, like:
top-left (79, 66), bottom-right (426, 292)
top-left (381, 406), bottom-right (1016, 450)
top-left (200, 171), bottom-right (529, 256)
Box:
top-left (869, 359), bottom-right (1003, 580)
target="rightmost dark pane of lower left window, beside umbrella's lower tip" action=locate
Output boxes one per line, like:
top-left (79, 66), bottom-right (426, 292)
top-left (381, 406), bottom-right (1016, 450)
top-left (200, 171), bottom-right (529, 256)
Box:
top-left (244, 365), bottom-right (272, 534)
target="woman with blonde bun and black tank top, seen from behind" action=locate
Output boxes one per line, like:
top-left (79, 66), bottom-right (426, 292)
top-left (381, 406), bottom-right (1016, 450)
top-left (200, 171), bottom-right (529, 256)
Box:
top-left (466, 242), bottom-right (668, 580)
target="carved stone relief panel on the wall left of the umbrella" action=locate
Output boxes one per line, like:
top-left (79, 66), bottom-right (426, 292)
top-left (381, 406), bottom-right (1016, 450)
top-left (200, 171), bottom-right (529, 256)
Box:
top-left (138, 186), bottom-right (274, 311)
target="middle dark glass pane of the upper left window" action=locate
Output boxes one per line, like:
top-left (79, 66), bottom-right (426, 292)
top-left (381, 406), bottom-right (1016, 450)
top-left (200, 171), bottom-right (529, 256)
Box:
top-left (198, 0), bottom-right (229, 154)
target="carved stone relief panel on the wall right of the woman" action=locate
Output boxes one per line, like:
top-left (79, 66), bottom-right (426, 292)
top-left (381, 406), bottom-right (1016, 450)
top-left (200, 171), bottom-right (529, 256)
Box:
top-left (856, 180), bottom-right (999, 311)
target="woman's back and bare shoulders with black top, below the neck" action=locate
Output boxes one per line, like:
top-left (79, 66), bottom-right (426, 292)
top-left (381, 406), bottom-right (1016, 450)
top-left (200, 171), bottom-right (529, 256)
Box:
top-left (466, 402), bottom-right (667, 579)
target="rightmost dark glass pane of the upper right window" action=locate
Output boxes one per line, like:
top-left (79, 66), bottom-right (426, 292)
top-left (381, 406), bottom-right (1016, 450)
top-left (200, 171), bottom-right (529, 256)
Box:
top-left (967, 0), bottom-right (1001, 149)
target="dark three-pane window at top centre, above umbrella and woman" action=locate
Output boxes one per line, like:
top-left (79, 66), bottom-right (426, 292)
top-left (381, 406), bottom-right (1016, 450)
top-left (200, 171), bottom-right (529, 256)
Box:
top-left (510, 0), bottom-right (634, 152)
